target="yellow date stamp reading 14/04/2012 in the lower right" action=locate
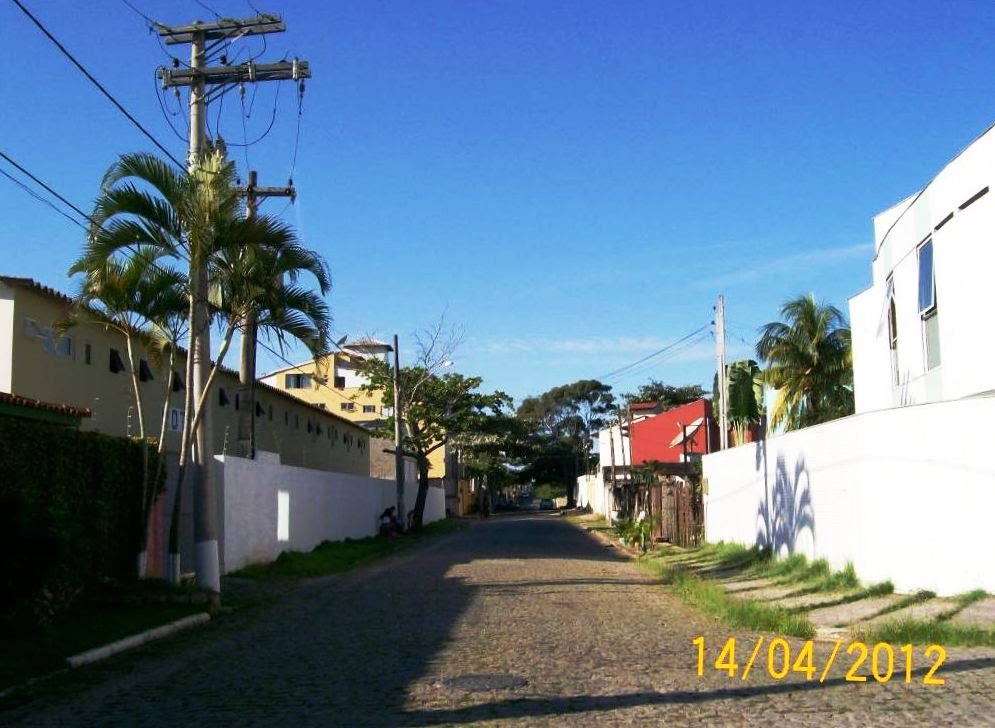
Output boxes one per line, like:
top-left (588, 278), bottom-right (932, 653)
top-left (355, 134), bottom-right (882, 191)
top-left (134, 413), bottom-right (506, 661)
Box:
top-left (691, 636), bottom-right (947, 685)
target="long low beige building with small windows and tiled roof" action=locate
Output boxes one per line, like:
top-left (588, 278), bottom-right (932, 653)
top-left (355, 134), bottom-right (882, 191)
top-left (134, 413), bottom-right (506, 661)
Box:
top-left (0, 276), bottom-right (370, 475)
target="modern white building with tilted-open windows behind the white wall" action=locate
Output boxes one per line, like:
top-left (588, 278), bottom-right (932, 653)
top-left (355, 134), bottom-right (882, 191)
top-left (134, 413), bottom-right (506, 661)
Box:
top-left (850, 122), bottom-right (995, 413)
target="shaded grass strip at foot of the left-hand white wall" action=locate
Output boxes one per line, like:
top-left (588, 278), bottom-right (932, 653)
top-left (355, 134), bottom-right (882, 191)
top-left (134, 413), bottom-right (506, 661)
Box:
top-left (232, 518), bottom-right (466, 580)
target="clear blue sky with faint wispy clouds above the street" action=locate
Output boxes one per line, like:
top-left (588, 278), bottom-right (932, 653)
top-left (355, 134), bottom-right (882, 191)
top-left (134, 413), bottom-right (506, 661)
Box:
top-left (0, 0), bottom-right (995, 398)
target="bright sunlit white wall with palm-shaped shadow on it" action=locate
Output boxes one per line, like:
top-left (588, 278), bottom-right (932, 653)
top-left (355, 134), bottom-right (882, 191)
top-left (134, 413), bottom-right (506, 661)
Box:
top-left (703, 397), bottom-right (995, 594)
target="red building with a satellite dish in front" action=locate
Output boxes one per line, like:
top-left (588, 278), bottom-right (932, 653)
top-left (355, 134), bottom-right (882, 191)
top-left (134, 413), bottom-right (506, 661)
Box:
top-left (630, 399), bottom-right (718, 465)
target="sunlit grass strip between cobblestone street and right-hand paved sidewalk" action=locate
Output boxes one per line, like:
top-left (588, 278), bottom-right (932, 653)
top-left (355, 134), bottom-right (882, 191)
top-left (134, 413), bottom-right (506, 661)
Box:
top-left (640, 558), bottom-right (815, 639)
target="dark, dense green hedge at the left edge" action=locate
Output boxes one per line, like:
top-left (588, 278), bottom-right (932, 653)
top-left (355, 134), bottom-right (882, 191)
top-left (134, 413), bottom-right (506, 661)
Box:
top-left (0, 416), bottom-right (162, 619)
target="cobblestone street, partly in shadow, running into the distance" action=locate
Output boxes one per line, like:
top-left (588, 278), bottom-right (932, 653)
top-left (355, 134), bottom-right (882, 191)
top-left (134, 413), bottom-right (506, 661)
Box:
top-left (7, 514), bottom-right (995, 726)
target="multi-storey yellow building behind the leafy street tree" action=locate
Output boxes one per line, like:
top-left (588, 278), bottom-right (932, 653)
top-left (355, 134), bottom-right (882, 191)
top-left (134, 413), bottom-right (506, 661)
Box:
top-left (260, 338), bottom-right (447, 480)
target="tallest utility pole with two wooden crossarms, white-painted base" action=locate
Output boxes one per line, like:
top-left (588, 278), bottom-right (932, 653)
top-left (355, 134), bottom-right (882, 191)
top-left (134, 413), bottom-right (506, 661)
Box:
top-left (155, 15), bottom-right (311, 592)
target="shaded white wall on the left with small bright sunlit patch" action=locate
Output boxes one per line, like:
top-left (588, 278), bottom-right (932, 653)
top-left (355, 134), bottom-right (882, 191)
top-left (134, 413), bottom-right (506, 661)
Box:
top-left (223, 454), bottom-right (446, 573)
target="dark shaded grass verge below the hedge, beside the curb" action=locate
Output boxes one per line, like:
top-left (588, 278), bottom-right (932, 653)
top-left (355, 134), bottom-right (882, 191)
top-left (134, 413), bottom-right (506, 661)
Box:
top-left (0, 601), bottom-right (207, 690)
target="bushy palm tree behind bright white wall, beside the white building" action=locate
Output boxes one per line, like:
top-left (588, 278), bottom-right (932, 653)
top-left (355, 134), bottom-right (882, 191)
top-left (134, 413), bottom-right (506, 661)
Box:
top-left (757, 294), bottom-right (853, 430)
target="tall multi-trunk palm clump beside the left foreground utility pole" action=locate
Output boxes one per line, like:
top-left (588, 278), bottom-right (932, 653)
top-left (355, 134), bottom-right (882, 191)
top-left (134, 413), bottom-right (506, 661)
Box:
top-left (79, 150), bottom-right (329, 589)
